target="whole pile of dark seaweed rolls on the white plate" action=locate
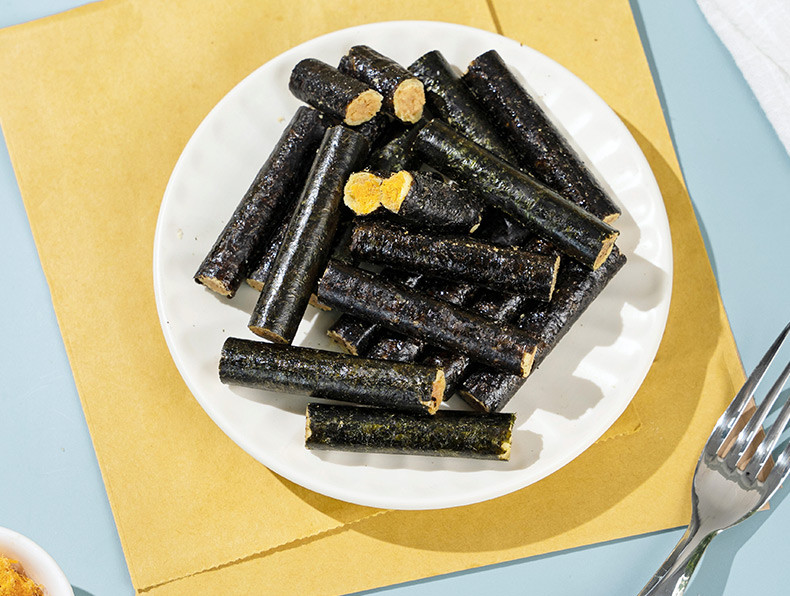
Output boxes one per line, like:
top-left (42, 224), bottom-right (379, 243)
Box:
top-left (194, 45), bottom-right (626, 460)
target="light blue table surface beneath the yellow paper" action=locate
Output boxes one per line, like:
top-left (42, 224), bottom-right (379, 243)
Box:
top-left (0, 0), bottom-right (790, 596)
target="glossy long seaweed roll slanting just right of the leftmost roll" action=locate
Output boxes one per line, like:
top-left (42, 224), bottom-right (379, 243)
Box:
top-left (248, 126), bottom-right (368, 343)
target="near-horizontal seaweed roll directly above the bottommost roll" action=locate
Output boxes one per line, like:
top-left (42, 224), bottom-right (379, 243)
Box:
top-left (219, 337), bottom-right (445, 414)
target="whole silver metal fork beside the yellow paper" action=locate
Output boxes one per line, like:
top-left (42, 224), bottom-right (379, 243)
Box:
top-left (638, 324), bottom-right (790, 596)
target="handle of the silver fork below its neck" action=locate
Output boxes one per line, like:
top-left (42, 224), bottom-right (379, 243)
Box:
top-left (637, 521), bottom-right (721, 596)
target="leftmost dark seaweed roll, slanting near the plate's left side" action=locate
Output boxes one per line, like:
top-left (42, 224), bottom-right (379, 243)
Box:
top-left (194, 106), bottom-right (327, 298)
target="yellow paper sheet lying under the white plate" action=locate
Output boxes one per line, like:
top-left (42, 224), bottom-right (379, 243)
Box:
top-left (0, 0), bottom-right (743, 595)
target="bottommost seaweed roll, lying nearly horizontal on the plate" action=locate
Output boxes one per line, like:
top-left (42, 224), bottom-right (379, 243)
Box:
top-left (305, 403), bottom-right (516, 461)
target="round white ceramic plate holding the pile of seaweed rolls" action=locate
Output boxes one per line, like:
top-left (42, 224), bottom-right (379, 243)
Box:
top-left (154, 22), bottom-right (672, 509)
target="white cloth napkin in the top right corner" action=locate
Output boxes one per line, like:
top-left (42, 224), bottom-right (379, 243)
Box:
top-left (697, 0), bottom-right (790, 153)
